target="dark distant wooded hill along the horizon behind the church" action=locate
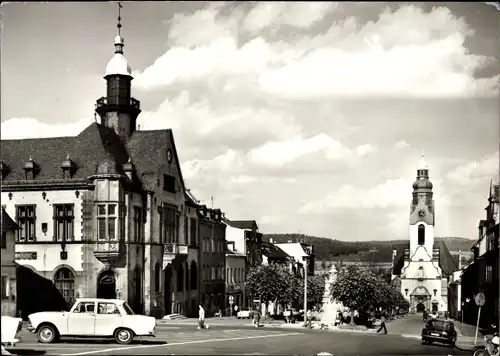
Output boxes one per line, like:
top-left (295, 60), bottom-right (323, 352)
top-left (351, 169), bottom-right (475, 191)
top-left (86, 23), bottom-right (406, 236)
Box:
top-left (264, 234), bottom-right (474, 263)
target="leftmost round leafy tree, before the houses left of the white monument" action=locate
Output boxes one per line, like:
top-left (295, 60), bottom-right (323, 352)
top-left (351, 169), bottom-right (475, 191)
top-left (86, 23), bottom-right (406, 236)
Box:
top-left (246, 264), bottom-right (297, 307)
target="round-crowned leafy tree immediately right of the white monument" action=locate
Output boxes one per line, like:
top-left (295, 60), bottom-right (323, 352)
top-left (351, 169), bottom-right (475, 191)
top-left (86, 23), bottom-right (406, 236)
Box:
top-left (330, 265), bottom-right (380, 324)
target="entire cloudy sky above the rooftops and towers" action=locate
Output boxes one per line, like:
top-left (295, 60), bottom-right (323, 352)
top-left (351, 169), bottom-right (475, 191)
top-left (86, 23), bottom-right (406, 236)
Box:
top-left (0, 2), bottom-right (500, 241)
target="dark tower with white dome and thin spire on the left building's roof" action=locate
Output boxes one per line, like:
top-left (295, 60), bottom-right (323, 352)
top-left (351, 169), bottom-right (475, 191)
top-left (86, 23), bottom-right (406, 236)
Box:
top-left (95, 3), bottom-right (141, 141)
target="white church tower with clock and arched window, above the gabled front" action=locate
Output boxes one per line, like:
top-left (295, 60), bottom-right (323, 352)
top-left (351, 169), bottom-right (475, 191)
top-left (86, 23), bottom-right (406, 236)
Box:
top-left (409, 153), bottom-right (435, 261)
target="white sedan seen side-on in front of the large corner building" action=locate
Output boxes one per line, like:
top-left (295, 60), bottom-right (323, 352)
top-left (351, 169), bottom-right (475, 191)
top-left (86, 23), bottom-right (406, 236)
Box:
top-left (28, 298), bottom-right (156, 344)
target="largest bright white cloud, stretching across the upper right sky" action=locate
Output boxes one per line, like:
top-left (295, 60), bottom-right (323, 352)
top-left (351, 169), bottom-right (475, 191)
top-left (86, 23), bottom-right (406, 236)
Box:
top-left (134, 3), bottom-right (500, 99)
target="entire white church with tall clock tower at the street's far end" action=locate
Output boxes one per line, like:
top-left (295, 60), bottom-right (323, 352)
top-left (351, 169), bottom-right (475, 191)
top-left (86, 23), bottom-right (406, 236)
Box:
top-left (392, 155), bottom-right (457, 313)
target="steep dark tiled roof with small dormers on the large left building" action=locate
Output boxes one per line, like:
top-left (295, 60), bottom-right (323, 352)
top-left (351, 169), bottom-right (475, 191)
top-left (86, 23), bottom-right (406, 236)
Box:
top-left (1, 122), bottom-right (184, 190)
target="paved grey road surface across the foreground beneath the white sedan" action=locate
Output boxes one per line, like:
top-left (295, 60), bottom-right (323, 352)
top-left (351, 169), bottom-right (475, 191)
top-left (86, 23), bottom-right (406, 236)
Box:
top-left (8, 324), bottom-right (470, 356)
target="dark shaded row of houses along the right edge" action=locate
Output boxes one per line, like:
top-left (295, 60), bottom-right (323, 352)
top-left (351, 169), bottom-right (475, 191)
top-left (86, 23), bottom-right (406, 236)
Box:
top-left (461, 183), bottom-right (500, 326)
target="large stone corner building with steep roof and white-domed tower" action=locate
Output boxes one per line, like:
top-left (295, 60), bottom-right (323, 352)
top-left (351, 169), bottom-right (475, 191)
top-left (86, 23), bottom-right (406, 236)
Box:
top-left (1, 11), bottom-right (199, 314)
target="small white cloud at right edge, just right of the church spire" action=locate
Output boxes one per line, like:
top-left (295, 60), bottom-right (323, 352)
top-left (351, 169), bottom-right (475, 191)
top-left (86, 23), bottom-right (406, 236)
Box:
top-left (447, 151), bottom-right (500, 186)
